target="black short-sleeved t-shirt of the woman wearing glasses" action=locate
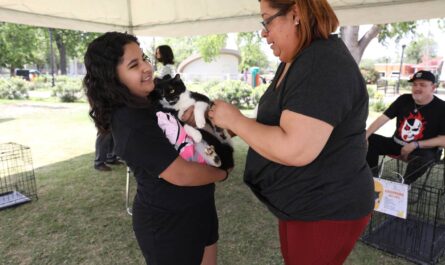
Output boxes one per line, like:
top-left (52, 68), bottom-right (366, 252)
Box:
top-left (244, 36), bottom-right (374, 221)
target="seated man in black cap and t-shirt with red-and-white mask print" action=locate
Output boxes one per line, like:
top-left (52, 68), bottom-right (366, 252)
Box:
top-left (366, 71), bottom-right (445, 184)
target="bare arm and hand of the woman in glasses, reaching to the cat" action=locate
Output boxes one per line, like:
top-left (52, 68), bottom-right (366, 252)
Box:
top-left (209, 100), bottom-right (333, 166)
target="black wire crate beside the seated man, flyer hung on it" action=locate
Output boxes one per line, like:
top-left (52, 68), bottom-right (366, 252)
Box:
top-left (361, 158), bottom-right (445, 264)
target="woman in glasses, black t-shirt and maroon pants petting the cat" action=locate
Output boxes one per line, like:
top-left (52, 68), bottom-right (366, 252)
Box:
top-left (209, 0), bottom-right (374, 265)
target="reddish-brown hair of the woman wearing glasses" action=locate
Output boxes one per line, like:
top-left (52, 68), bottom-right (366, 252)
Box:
top-left (259, 0), bottom-right (339, 55)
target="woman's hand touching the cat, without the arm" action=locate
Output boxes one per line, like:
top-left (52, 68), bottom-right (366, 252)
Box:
top-left (208, 100), bottom-right (243, 129)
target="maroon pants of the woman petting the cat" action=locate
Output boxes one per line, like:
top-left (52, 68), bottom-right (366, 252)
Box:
top-left (279, 214), bottom-right (371, 265)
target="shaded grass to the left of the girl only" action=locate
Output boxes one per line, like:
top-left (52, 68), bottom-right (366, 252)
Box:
top-left (0, 154), bottom-right (143, 264)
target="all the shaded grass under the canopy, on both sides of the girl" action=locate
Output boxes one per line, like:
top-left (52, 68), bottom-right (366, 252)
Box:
top-left (0, 145), bottom-right (414, 265)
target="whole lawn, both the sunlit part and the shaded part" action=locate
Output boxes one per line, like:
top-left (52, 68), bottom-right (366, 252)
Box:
top-left (0, 101), bottom-right (411, 265)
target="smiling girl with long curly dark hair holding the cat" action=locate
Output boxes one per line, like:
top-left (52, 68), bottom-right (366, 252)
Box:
top-left (84, 32), bottom-right (228, 265)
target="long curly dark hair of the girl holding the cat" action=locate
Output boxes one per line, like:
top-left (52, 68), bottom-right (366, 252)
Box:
top-left (83, 32), bottom-right (147, 134)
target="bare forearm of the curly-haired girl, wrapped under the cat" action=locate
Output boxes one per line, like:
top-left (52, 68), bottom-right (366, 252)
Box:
top-left (160, 156), bottom-right (228, 186)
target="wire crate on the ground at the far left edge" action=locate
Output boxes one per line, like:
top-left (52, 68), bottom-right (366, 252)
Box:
top-left (0, 143), bottom-right (38, 210)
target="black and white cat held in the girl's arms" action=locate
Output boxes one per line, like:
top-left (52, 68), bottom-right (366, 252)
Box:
top-left (154, 74), bottom-right (234, 169)
